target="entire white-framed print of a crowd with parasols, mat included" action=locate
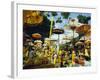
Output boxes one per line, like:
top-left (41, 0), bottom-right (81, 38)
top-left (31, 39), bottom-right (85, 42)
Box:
top-left (11, 2), bottom-right (96, 78)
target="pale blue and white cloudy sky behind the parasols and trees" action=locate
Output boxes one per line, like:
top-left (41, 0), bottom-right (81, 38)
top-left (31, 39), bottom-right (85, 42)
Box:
top-left (45, 12), bottom-right (91, 41)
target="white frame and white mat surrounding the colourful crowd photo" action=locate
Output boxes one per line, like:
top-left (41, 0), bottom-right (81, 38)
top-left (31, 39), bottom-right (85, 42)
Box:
top-left (11, 2), bottom-right (97, 78)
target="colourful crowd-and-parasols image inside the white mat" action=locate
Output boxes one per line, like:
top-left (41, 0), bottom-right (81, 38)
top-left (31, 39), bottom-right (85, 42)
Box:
top-left (22, 9), bottom-right (92, 70)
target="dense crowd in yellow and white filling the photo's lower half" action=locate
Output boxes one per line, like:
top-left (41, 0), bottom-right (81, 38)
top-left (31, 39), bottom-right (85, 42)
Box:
top-left (23, 39), bottom-right (91, 68)
